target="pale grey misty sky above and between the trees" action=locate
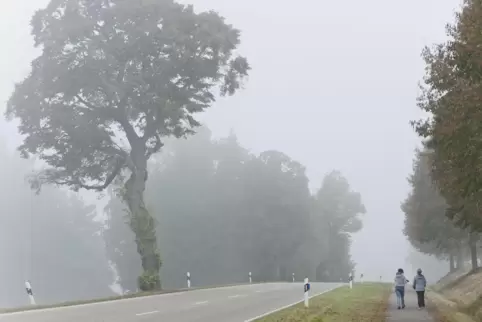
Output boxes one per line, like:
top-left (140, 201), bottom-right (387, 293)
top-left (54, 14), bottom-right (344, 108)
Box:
top-left (0, 0), bottom-right (460, 278)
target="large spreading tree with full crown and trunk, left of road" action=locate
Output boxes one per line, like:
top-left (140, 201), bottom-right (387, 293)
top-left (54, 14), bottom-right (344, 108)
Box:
top-left (6, 0), bottom-right (249, 290)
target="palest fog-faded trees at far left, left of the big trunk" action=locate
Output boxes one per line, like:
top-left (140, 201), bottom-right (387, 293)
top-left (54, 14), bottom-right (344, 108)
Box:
top-left (0, 144), bottom-right (114, 308)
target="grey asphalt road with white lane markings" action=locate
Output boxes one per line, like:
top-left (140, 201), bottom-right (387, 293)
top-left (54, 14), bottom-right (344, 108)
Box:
top-left (0, 283), bottom-right (342, 322)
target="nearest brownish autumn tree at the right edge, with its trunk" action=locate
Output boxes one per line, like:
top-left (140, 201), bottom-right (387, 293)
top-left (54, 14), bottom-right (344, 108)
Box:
top-left (414, 0), bottom-right (482, 270)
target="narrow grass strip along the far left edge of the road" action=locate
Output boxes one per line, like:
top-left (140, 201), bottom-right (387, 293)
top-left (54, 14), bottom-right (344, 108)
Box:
top-left (0, 283), bottom-right (259, 314)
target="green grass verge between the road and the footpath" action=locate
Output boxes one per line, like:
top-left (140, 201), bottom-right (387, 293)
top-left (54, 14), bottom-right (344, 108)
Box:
top-left (256, 283), bottom-right (391, 322)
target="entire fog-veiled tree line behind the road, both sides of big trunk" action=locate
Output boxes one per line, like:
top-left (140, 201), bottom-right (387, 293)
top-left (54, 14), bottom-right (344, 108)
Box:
top-left (0, 127), bottom-right (365, 307)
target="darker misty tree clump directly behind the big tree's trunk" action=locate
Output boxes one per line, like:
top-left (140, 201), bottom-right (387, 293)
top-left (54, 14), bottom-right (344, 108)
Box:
top-left (105, 127), bottom-right (365, 291)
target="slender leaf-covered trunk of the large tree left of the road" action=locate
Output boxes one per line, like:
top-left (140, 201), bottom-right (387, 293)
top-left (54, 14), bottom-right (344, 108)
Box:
top-left (124, 165), bottom-right (161, 291)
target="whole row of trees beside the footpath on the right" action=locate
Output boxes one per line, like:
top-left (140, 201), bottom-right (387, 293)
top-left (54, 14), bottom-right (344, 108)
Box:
top-left (402, 0), bottom-right (482, 270)
